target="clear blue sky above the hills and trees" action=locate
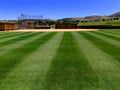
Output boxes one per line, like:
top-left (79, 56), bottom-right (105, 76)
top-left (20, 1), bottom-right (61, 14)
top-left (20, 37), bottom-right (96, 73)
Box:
top-left (0, 0), bottom-right (120, 20)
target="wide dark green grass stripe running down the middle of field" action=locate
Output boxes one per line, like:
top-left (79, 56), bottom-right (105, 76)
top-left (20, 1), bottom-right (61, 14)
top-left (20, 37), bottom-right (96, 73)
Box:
top-left (46, 32), bottom-right (99, 90)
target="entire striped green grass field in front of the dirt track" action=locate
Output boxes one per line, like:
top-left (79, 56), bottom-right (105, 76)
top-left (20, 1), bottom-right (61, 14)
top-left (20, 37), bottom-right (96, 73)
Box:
top-left (0, 29), bottom-right (120, 90)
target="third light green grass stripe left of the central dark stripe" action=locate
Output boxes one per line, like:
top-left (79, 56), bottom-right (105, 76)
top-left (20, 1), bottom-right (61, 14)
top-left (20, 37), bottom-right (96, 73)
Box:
top-left (0, 33), bottom-right (31, 43)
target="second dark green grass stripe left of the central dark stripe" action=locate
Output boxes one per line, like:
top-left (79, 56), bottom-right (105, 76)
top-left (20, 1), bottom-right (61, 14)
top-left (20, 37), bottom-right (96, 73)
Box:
top-left (0, 32), bottom-right (40, 47)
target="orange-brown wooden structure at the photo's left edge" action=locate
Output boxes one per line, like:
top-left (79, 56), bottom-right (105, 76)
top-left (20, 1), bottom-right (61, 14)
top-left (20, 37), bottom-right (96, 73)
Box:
top-left (0, 22), bottom-right (17, 31)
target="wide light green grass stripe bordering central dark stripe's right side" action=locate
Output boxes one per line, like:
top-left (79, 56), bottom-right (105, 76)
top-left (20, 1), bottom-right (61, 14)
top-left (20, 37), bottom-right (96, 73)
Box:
top-left (73, 32), bottom-right (120, 90)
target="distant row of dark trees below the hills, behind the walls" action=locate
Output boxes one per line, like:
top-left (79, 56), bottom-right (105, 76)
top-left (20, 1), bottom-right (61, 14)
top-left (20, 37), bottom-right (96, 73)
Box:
top-left (18, 17), bottom-right (120, 26)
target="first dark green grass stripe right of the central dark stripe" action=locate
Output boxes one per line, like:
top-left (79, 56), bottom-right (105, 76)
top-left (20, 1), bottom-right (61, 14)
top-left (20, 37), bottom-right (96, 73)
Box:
top-left (80, 32), bottom-right (120, 62)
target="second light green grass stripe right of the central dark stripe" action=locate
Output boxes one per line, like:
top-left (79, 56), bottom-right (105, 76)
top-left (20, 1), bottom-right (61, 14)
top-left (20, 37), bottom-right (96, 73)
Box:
top-left (85, 32), bottom-right (120, 47)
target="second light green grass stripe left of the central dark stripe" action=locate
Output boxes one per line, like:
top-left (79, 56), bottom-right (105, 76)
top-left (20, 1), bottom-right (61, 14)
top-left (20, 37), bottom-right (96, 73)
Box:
top-left (0, 32), bottom-right (48, 56)
